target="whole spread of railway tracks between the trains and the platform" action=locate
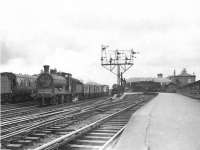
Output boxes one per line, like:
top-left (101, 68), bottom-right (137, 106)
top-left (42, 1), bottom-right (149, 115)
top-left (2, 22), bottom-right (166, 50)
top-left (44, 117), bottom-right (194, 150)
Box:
top-left (1, 94), bottom-right (154, 150)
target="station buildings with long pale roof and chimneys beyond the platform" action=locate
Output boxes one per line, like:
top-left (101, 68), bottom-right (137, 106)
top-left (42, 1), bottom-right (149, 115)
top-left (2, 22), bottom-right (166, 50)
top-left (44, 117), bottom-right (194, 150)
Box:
top-left (126, 68), bottom-right (196, 92)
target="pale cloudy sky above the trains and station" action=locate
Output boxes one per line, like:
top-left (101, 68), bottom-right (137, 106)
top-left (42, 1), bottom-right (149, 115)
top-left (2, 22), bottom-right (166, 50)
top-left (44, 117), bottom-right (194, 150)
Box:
top-left (0, 0), bottom-right (200, 85)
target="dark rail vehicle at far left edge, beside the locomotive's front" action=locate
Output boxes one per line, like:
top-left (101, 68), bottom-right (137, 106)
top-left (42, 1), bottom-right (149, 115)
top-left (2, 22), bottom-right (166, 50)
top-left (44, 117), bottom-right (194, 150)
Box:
top-left (1, 72), bottom-right (37, 103)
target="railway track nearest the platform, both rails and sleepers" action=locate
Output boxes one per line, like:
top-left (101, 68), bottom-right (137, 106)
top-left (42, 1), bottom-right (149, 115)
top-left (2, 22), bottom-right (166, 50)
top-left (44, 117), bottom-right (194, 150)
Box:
top-left (35, 97), bottom-right (145, 150)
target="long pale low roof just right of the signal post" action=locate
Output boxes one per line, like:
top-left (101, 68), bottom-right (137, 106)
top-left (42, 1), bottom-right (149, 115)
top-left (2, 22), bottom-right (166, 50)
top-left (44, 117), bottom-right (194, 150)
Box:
top-left (127, 77), bottom-right (172, 83)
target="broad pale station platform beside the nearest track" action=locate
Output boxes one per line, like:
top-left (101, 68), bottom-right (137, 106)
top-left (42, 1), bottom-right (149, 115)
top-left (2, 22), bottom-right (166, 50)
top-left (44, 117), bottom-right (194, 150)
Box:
top-left (114, 93), bottom-right (200, 150)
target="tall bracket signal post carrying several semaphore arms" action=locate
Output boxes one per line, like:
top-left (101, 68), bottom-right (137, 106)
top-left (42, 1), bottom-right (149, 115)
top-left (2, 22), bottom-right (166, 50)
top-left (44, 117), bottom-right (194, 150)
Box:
top-left (101, 45), bottom-right (138, 85)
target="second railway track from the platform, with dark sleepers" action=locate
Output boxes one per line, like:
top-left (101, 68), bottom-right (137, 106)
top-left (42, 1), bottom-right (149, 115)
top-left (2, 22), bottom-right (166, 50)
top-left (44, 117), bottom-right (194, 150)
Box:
top-left (2, 94), bottom-right (152, 150)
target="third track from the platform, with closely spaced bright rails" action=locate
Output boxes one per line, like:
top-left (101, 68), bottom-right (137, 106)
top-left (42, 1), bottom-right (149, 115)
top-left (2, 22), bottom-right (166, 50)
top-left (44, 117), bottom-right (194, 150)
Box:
top-left (0, 98), bottom-right (112, 141)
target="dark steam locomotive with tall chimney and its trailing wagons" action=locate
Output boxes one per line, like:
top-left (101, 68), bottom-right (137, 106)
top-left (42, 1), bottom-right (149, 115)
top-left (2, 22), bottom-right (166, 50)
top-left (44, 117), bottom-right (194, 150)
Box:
top-left (36, 65), bottom-right (109, 105)
